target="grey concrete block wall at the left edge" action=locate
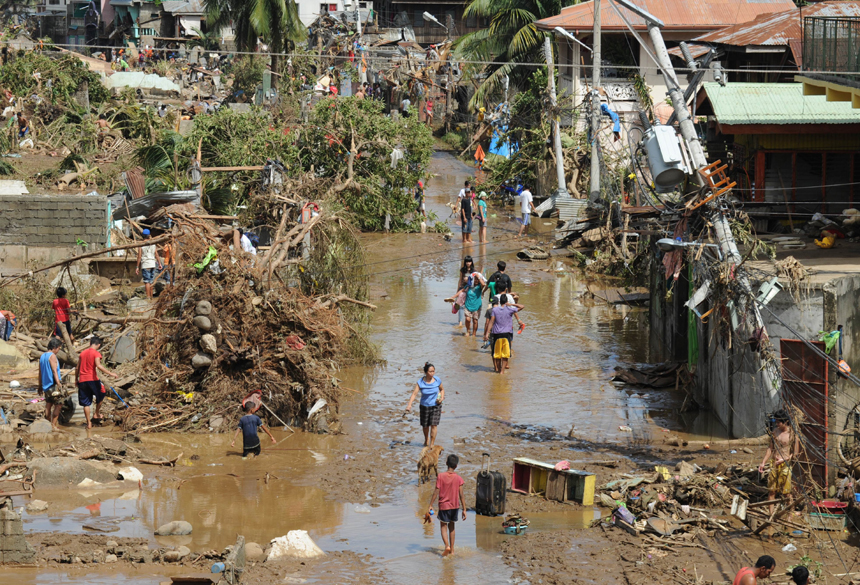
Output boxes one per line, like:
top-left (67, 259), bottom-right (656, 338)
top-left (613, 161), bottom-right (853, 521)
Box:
top-left (0, 195), bottom-right (107, 249)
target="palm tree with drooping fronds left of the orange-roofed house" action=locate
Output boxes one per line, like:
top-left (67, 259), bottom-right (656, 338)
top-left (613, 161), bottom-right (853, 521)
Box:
top-left (454, 0), bottom-right (580, 109)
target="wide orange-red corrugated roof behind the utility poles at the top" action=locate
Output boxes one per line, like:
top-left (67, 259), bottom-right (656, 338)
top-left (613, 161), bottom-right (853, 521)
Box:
top-left (535, 0), bottom-right (794, 31)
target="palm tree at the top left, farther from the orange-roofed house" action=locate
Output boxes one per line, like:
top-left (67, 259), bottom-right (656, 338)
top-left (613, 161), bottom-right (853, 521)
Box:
top-left (203, 0), bottom-right (307, 71)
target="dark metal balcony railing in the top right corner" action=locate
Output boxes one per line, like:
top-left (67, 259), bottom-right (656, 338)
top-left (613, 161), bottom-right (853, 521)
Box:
top-left (803, 16), bottom-right (860, 73)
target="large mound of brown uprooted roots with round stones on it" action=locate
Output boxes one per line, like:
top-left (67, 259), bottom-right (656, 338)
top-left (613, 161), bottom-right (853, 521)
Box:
top-left (123, 205), bottom-right (375, 432)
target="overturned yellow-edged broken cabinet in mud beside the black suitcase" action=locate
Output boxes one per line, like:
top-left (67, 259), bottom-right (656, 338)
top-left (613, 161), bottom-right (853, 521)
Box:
top-left (511, 457), bottom-right (596, 506)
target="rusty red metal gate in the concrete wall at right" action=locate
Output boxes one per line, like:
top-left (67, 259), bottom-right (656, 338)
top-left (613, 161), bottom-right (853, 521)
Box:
top-left (780, 339), bottom-right (829, 488)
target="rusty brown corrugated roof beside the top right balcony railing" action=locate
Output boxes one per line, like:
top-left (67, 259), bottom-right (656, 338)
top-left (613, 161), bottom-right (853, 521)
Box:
top-left (693, 0), bottom-right (860, 47)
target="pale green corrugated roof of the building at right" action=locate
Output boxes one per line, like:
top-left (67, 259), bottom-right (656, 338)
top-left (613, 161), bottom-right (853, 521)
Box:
top-left (704, 82), bottom-right (860, 125)
